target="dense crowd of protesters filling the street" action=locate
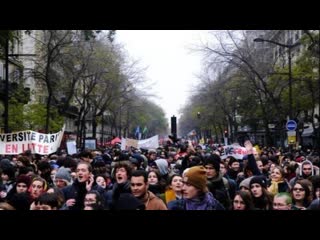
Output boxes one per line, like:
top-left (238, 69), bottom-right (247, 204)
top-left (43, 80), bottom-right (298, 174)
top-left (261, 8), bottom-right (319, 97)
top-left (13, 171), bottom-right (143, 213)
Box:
top-left (0, 138), bottom-right (320, 210)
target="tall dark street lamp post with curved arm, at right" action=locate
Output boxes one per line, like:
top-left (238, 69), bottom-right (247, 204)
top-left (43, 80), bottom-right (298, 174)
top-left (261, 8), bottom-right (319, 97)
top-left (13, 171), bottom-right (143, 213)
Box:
top-left (253, 38), bottom-right (300, 119)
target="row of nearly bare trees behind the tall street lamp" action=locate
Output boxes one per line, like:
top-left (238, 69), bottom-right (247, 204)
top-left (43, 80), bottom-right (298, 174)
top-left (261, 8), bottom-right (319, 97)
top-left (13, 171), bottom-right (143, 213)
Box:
top-left (180, 31), bottom-right (320, 145)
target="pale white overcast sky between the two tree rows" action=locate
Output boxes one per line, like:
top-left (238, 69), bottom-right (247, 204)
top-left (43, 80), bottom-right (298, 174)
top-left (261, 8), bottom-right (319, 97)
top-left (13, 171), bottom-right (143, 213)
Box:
top-left (116, 30), bottom-right (209, 121)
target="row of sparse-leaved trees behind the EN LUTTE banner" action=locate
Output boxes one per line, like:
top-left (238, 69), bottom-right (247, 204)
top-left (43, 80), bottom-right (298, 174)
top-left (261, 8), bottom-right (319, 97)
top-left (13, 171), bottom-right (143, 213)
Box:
top-left (1, 30), bottom-right (167, 147)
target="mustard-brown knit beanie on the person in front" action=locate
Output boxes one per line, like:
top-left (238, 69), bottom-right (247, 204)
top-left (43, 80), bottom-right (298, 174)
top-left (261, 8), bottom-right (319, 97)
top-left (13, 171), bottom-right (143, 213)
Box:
top-left (184, 166), bottom-right (208, 192)
